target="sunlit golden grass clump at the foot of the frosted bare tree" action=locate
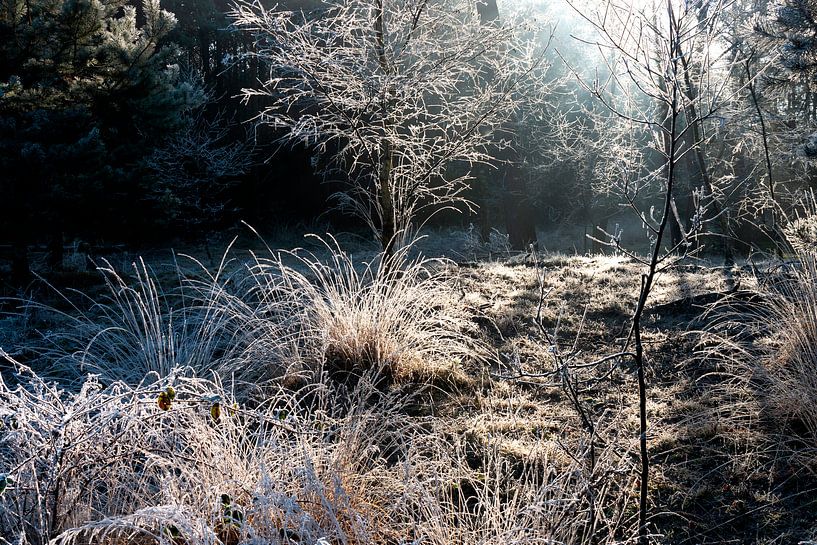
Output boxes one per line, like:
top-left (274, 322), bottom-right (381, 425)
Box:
top-left (245, 239), bottom-right (486, 382)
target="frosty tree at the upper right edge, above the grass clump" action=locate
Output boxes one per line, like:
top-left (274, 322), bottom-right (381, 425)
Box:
top-left (725, 0), bottom-right (817, 251)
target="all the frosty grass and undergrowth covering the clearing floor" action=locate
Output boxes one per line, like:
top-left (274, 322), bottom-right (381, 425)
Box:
top-left (9, 238), bottom-right (817, 545)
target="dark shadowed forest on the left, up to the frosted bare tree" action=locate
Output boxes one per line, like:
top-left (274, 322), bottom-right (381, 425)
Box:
top-left (0, 0), bottom-right (337, 280)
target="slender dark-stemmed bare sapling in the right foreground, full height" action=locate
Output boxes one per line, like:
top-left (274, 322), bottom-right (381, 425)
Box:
top-left (560, 0), bottom-right (740, 545)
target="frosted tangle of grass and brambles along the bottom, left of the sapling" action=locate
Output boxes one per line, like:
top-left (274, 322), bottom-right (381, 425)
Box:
top-left (0, 352), bottom-right (632, 545)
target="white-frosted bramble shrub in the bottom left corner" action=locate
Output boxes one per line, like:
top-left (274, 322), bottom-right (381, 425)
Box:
top-left (0, 365), bottom-right (239, 544)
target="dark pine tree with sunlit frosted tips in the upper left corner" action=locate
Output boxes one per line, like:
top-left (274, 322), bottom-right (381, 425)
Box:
top-left (0, 0), bottom-right (203, 278)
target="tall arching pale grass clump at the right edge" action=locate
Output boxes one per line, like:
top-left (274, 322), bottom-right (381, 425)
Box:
top-left (700, 244), bottom-right (817, 463)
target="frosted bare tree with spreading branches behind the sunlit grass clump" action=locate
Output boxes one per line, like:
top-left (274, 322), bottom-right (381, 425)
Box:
top-left (232, 0), bottom-right (546, 253)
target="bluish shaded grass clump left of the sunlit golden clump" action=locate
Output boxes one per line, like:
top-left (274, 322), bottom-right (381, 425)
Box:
top-left (10, 253), bottom-right (302, 385)
